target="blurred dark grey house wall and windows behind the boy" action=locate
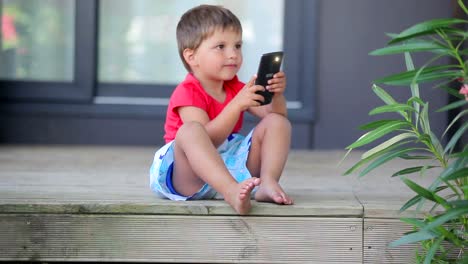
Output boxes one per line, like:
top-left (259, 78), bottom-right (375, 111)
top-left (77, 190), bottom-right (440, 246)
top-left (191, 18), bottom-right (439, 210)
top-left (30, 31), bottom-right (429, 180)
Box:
top-left (0, 0), bottom-right (462, 149)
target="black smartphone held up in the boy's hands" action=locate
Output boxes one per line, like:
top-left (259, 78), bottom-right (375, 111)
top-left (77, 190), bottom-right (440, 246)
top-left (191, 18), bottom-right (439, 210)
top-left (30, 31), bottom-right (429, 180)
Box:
top-left (255, 51), bottom-right (283, 105)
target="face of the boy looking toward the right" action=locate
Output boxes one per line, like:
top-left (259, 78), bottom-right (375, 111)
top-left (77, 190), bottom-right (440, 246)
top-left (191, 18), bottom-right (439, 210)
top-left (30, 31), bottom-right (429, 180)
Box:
top-left (189, 29), bottom-right (242, 81)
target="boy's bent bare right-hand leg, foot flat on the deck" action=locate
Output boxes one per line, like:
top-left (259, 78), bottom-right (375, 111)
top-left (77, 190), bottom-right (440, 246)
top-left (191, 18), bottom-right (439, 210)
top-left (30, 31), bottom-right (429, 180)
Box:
top-left (247, 114), bottom-right (293, 204)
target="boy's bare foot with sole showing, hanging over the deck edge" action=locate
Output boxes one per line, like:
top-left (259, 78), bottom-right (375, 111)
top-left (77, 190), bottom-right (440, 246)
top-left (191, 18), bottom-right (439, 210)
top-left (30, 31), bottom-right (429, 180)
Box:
top-left (224, 177), bottom-right (260, 215)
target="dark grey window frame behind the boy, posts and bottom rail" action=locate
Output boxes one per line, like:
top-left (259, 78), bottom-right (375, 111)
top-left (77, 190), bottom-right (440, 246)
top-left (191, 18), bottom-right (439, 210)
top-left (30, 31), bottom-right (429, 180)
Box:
top-left (0, 0), bottom-right (318, 121)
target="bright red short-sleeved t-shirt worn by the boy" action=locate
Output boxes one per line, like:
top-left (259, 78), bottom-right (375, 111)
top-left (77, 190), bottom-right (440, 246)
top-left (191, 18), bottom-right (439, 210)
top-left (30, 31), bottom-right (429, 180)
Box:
top-left (164, 73), bottom-right (245, 143)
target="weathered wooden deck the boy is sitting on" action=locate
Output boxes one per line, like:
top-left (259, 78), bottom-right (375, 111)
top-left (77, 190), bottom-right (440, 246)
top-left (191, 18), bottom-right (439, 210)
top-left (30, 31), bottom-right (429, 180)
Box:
top-left (0, 145), bottom-right (433, 263)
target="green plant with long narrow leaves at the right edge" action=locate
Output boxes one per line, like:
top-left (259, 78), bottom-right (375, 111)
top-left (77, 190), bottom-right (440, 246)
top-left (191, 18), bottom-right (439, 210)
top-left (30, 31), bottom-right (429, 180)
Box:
top-left (345, 0), bottom-right (468, 263)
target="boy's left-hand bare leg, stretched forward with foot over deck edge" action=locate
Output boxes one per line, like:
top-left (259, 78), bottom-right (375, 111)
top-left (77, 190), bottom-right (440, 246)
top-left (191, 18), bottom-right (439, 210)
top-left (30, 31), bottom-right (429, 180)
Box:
top-left (172, 122), bottom-right (260, 214)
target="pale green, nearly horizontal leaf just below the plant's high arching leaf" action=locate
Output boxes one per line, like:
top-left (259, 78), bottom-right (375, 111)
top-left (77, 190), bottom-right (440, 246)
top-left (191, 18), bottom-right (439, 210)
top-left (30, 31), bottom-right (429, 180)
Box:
top-left (369, 40), bottom-right (448, 56)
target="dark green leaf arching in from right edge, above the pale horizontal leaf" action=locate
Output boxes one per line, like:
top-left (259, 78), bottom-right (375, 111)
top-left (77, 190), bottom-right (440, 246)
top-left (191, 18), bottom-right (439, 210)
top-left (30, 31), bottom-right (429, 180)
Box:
top-left (389, 18), bottom-right (468, 44)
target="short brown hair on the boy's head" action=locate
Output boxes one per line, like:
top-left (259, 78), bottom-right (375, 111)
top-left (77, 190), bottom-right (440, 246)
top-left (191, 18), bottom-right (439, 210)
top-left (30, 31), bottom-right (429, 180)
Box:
top-left (176, 5), bottom-right (242, 72)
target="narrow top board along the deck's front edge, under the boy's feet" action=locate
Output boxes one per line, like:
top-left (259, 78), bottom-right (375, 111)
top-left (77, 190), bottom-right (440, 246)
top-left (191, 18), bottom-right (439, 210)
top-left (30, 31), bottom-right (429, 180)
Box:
top-left (0, 195), bottom-right (362, 217)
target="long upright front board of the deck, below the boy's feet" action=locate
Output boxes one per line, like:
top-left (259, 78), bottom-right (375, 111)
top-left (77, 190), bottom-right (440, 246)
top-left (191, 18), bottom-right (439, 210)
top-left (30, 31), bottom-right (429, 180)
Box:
top-left (0, 214), bottom-right (362, 263)
